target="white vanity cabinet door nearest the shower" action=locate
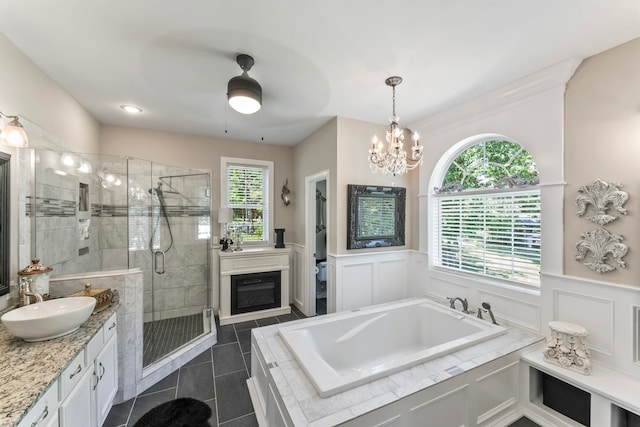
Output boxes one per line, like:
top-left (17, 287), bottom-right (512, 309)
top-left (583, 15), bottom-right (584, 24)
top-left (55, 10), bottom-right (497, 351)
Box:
top-left (93, 336), bottom-right (118, 426)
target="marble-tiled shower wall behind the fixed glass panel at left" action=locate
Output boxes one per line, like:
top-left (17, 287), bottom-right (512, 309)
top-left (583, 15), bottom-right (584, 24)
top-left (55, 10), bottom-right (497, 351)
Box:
top-left (27, 155), bottom-right (128, 275)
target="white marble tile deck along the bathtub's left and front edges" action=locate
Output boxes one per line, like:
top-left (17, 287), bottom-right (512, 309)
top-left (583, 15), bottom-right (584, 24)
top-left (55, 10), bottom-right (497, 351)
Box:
top-left (252, 312), bottom-right (543, 427)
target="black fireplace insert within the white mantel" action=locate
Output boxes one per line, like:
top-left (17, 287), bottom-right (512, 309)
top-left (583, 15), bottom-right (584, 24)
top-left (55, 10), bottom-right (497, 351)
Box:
top-left (231, 271), bottom-right (281, 315)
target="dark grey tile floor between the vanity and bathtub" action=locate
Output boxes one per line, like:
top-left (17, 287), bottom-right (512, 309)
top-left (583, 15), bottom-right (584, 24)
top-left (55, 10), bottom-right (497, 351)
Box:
top-left (103, 307), bottom-right (305, 427)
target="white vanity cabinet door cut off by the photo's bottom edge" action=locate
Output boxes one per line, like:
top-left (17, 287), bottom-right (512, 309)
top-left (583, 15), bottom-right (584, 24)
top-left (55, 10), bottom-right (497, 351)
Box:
top-left (58, 369), bottom-right (95, 427)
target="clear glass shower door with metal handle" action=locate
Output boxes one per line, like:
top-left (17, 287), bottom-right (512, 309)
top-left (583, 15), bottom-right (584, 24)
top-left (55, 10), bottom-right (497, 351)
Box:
top-left (128, 162), bottom-right (213, 367)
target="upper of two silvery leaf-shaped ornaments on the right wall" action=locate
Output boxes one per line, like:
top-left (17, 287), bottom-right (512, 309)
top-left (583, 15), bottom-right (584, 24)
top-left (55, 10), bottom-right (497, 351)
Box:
top-left (576, 179), bottom-right (629, 225)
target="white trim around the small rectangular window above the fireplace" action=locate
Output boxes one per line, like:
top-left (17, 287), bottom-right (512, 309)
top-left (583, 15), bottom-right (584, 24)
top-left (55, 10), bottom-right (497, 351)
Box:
top-left (220, 157), bottom-right (275, 246)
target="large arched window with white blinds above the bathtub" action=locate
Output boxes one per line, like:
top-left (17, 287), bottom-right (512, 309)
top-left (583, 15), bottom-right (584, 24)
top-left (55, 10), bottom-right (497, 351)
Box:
top-left (431, 138), bottom-right (540, 286)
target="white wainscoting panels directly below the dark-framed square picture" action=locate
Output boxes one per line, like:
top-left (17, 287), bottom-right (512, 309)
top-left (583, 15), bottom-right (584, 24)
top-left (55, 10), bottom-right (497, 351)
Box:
top-left (327, 250), bottom-right (411, 311)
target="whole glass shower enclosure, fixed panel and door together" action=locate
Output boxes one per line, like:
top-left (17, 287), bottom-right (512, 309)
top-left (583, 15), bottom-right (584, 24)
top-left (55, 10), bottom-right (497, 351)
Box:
top-left (26, 147), bottom-right (213, 367)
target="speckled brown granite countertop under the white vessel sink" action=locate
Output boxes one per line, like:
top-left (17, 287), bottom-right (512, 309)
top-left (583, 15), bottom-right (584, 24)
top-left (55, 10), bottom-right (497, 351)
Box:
top-left (0, 305), bottom-right (117, 427)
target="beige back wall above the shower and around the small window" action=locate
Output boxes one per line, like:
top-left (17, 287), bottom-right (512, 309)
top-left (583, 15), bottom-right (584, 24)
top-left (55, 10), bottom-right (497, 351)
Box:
top-left (100, 125), bottom-right (294, 241)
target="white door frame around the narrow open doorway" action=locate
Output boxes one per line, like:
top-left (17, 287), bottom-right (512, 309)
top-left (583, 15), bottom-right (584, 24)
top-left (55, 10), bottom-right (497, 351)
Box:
top-left (303, 169), bottom-right (333, 316)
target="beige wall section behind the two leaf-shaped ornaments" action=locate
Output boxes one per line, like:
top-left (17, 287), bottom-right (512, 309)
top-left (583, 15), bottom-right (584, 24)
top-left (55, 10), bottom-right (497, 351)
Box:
top-left (564, 38), bottom-right (640, 286)
